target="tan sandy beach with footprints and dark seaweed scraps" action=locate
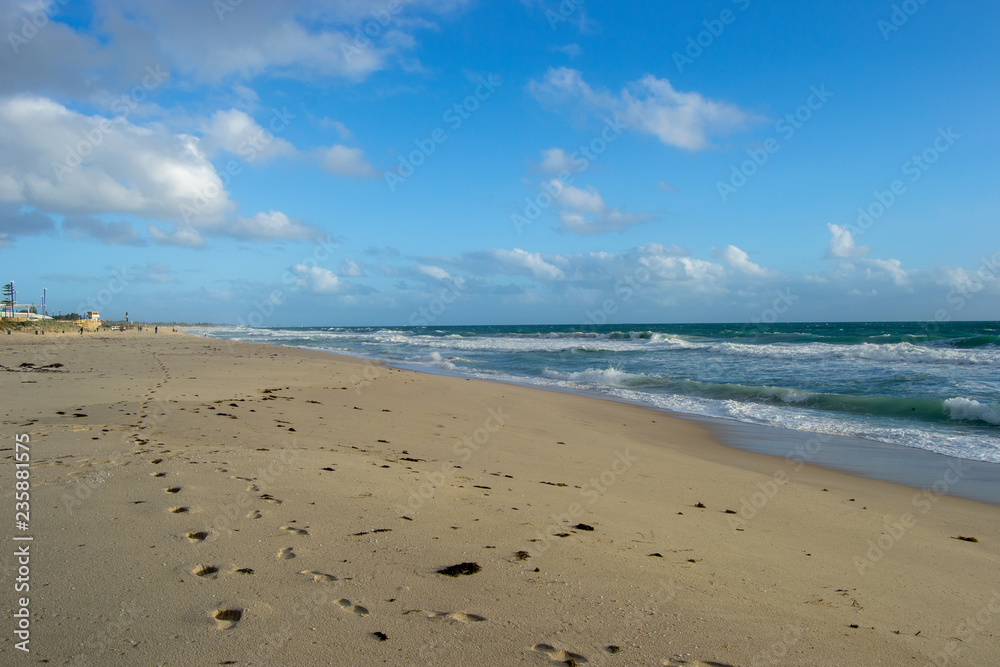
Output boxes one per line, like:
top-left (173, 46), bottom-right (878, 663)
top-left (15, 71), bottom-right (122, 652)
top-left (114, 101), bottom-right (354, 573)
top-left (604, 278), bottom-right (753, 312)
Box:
top-left (0, 329), bottom-right (1000, 667)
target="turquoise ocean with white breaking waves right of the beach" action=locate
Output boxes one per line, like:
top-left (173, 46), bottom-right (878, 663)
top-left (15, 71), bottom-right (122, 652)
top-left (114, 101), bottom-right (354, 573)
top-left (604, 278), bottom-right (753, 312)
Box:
top-left (189, 322), bottom-right (1000, 463)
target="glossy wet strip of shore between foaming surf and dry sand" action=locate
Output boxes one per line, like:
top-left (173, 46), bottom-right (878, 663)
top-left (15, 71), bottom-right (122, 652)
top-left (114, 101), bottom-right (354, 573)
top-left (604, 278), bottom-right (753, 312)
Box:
top-left (187, 333), bottom-right (1000, 506)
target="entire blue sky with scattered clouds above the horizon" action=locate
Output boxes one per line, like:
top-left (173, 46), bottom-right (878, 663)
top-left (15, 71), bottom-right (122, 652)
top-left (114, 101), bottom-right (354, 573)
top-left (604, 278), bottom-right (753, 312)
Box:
top-left (0, 0), bottom-right (1000, 326)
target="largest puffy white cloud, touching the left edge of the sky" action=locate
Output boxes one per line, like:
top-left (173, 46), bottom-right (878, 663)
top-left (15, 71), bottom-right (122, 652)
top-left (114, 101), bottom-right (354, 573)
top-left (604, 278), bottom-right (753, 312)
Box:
top-left (0, 96), bottom-right (233, 220)
